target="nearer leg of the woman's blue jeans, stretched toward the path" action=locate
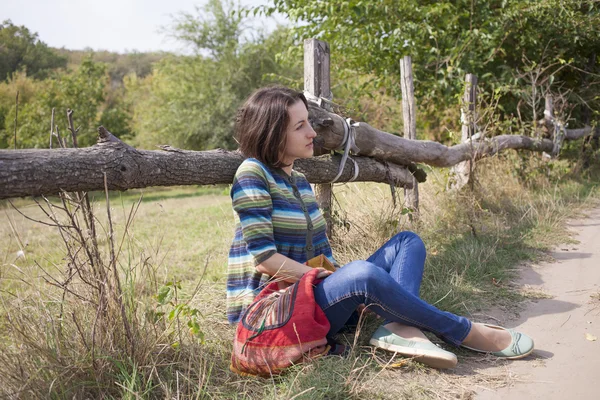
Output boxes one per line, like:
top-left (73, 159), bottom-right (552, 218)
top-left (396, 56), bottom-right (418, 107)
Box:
top-left (315, 261), bottom-right (471, 345)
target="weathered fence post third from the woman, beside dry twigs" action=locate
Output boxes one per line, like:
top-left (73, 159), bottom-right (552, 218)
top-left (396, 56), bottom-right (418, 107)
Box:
top-left (452, 74), bottom-right (477, 190)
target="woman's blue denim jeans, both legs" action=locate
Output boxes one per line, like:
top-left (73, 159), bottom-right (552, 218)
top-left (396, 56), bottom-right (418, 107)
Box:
top-left (315, 232), bottom-right (471, 346)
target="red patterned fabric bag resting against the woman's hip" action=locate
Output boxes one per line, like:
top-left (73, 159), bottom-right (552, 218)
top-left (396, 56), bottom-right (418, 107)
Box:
top-left (230, 269), bottom-right (330, 377)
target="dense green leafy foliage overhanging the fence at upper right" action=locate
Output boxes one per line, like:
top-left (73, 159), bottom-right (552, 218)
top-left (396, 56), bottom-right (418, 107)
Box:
top-left (270, 0), bottom-right (600, 131)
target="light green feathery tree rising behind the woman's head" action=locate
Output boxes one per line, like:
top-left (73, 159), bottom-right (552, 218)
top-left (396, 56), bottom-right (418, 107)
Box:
top-left (125, 0), bottom-right (301, 150)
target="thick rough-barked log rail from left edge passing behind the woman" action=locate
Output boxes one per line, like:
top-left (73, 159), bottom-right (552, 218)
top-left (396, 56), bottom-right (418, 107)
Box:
top-left (0, 127), bottom-right (413, 199)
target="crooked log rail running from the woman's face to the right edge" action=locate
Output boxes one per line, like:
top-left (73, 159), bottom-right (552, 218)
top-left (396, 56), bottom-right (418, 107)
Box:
top-left (309, 102), bottom-right (594, 167)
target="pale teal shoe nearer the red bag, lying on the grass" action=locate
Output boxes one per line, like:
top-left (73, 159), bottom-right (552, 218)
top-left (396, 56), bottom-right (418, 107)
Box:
top-left (369, 326), bottom-right (458, 369)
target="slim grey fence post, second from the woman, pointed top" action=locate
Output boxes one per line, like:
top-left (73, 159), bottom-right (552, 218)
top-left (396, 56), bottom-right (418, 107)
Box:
top-left (400, 56), bottom-right (419, 217)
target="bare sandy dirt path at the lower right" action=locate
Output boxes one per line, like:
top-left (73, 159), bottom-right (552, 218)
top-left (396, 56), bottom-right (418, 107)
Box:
top-left (477, 208), bottom-right (600, 400)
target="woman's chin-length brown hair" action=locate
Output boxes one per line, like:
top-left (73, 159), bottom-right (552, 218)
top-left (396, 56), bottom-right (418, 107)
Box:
top-left (235, 86), bottom-right (308, 168)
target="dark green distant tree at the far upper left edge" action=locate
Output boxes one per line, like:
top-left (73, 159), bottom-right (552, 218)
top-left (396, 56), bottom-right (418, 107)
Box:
top-left (0, 20), bottom-right (67, 81)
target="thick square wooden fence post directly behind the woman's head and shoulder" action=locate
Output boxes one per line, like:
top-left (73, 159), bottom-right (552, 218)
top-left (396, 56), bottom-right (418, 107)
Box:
top-left (304, 39), bottom-right (333, 238)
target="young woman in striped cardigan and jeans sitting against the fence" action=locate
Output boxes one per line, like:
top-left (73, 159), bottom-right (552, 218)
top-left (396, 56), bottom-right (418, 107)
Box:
top-left (227, 87), bottom-right (533, 368)
